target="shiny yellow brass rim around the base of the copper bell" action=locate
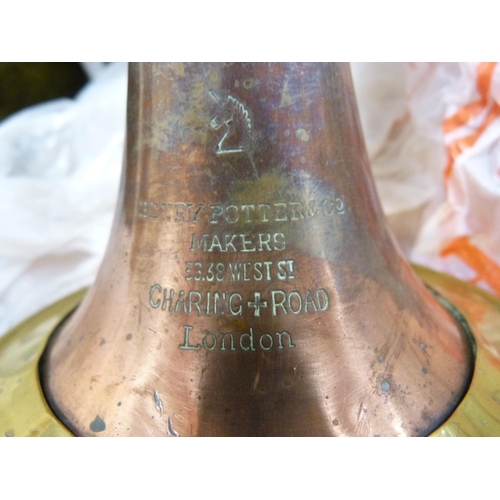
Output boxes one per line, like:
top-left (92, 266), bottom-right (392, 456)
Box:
top-left (0, 266), bottom-right (500, 437)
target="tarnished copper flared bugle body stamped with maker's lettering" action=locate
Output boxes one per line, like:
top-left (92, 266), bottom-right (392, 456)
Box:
top-left (42, 63), bottom-right (473, 436)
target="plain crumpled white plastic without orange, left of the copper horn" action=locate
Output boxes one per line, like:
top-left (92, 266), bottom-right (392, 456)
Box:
top-left (0, 64), bottom-right (127, 335)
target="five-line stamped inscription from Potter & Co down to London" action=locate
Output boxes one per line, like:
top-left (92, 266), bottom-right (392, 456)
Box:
top-left (143, 192), bottom-right (345, 352)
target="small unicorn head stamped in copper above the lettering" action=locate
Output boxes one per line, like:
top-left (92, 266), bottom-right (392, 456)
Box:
top-left (208, 90), bottom-right (258, 177)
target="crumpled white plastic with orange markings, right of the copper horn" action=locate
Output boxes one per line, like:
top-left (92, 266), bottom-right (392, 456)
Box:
top-left (353, 63), bottom-right (500, 295)
